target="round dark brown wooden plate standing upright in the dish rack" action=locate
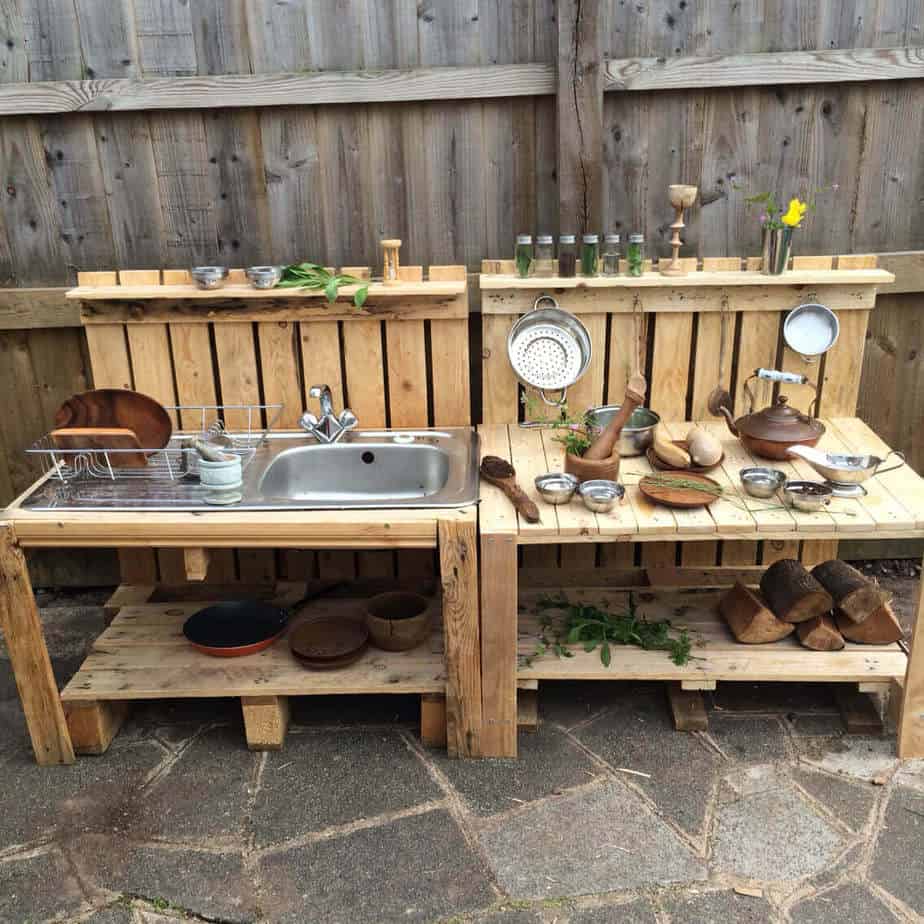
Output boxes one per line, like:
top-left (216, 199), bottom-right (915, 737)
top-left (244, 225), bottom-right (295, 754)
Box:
top-left (55, 388), bottom-right (173, 450)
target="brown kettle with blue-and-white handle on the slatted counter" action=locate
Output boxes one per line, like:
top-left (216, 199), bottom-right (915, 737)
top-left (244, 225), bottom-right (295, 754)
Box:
top-left (718, 369), bottom-right (825, 460)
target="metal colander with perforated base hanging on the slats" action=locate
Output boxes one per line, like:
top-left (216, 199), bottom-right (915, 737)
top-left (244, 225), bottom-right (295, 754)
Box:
top-left (507, 295), bottom-right (591, 407)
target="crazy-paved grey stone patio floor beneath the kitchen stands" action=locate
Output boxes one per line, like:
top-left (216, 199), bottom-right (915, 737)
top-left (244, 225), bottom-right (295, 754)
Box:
top-left (0, 591), bottom-right (924, 924)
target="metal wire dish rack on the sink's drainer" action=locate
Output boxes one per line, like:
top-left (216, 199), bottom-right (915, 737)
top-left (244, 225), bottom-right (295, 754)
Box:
top-left (26, 404), bottom-right (283, 483)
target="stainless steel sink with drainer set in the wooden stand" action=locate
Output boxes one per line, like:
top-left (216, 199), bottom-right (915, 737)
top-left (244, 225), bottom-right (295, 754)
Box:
top-left (23, 427), bottom-right (479, 511)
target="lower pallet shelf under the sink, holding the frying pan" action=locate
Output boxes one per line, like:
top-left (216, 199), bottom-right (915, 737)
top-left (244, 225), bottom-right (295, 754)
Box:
top-left (61, 599), bottom-right (446, 703)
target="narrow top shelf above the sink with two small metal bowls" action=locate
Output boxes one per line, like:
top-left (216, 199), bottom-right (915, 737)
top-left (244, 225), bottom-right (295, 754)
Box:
top-left (65, 280), bottom-right (466, 302)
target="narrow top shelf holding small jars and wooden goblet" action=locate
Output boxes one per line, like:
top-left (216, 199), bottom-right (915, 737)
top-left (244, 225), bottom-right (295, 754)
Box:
top-left (479, 269), bottom-right (895, 289)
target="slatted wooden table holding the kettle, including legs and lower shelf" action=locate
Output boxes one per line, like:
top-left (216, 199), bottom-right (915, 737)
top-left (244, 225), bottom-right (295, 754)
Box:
top-left (479, 417), bottom-right (924, 757)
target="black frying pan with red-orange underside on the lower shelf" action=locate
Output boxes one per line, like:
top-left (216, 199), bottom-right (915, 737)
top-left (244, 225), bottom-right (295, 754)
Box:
top-left (183, 581), bottom-right (341, 658)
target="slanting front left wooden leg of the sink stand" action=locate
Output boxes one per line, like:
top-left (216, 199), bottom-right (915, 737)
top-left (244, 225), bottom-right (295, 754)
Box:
top-left (0, 525), bottom-right (74, 765)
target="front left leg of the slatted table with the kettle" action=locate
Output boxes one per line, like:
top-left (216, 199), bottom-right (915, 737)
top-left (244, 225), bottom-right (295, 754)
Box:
top-left (481, 534), bottom-right (517, 757)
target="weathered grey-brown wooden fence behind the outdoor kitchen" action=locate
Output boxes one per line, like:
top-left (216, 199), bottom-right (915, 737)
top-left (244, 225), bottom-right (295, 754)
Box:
top-left (0, 0), bottom-right (924, 580)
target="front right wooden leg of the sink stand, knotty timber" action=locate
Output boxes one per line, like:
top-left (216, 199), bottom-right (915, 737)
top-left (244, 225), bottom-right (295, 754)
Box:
top-left (438, 516), bottom-right (481, 757)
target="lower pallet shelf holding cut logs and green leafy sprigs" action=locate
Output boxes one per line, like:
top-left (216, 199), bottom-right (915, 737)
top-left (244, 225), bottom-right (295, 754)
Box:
top-left (517, 587), bottom-right (907, 688)
